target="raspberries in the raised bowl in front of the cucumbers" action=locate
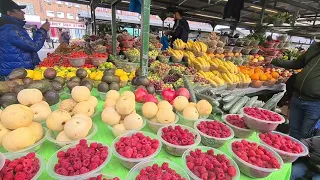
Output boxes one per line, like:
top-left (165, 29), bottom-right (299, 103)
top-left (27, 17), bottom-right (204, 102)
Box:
top-left (243, 107), bottom-right (282, 122)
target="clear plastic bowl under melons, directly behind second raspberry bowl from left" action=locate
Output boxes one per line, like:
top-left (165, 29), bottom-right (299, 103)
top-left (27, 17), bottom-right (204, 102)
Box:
top-left (46, 122), bottom-right (98, 148)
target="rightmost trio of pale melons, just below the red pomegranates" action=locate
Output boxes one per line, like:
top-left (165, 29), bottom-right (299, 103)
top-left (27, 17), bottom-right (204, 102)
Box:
top-left (173, 96), bottom-right (212, 121)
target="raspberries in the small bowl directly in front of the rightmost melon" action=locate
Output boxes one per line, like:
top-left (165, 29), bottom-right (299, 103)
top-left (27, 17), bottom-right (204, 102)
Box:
top-left (197, 121), bottom-right (232, 138)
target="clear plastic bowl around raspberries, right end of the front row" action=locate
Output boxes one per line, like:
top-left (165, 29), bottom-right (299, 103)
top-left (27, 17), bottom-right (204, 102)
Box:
top-left (228, 139), bottom-right (283, 178)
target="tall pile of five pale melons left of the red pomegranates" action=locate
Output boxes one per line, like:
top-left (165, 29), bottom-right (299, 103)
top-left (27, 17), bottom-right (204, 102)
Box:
top-left (101, 90), bottom-right (144, 136)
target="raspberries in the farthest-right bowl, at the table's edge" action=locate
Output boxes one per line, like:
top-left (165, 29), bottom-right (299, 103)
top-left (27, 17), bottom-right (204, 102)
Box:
top-left (259, 132), bottom-right (304, 154)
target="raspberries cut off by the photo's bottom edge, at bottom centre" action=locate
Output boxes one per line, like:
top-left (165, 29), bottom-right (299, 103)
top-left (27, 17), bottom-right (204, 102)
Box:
top-left (136, 163), bottom-right (186, 180)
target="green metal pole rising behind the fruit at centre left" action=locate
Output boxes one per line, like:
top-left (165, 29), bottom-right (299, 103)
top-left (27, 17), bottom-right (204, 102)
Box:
top-left (140, 0), bottom-right (151, 76)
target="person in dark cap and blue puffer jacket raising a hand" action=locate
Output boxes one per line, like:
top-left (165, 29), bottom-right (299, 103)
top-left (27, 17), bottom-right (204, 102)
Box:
top-left (0, 0), bottom-right (50, 77)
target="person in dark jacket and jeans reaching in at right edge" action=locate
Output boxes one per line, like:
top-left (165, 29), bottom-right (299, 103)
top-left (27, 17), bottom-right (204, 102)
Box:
top-left (271, 43), bottom-right (320, 139)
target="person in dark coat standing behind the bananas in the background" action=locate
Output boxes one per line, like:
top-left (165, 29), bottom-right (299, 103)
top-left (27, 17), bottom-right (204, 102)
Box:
top-left (169, 10), bottom-right (190, 42)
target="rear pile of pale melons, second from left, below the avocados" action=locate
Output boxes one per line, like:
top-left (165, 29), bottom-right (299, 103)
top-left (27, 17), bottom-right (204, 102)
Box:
top-left (58, 86), bottom-right (98, 117)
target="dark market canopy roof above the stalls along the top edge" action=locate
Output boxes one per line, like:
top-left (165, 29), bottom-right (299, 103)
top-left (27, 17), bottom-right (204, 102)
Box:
top-left (65, 0), bottom-right (320, 37)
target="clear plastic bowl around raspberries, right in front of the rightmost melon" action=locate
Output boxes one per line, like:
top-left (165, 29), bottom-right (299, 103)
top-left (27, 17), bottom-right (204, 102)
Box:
top-left (194, 119), bottom-right (234, 148)
